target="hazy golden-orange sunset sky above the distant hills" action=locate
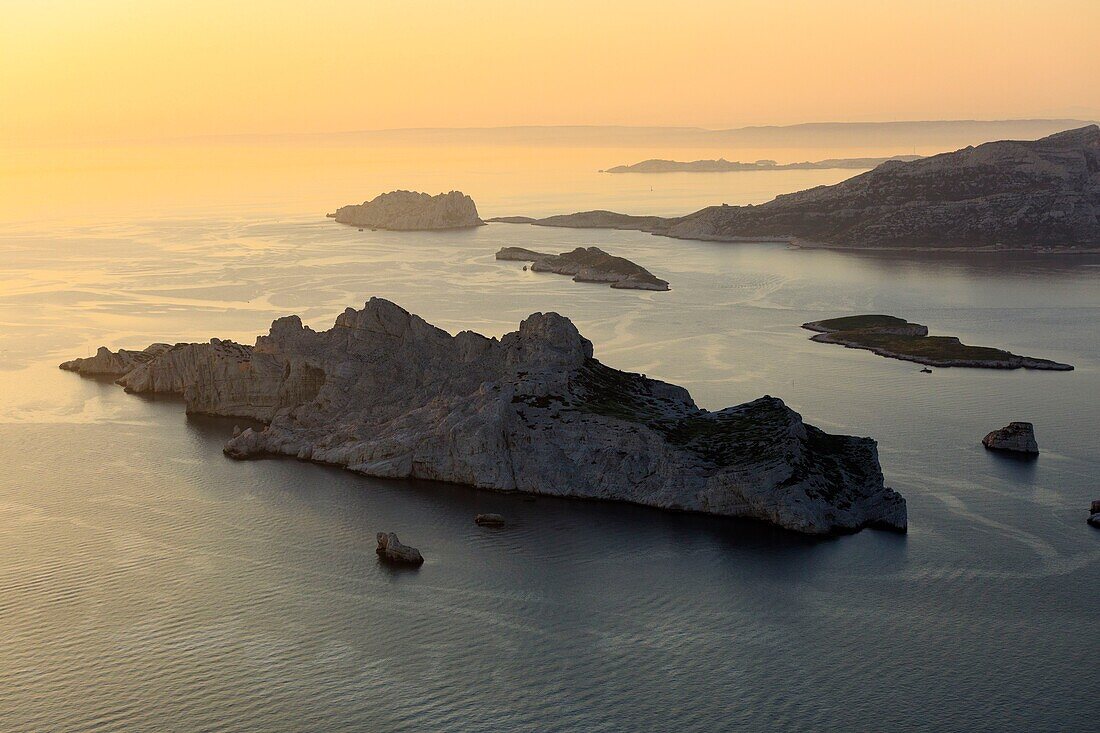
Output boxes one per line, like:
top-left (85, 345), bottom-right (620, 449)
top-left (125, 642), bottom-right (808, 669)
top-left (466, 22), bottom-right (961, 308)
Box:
top-left (0, 0), bottom-right (1100, 144)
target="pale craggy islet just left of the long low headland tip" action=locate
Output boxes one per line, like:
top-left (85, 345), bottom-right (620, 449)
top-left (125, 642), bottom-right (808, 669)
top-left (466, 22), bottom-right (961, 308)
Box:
top-left (328, 190), bottom-right (485, 231)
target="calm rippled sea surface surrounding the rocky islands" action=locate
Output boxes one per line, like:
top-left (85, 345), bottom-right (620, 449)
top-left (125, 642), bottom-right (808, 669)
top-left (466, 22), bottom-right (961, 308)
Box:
top-left (0, 149), bottom-right (1100, 732)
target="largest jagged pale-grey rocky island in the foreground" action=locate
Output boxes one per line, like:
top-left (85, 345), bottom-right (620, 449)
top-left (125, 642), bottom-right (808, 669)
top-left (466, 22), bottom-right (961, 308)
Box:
top-left (62, 298), bottom-right (906, 535)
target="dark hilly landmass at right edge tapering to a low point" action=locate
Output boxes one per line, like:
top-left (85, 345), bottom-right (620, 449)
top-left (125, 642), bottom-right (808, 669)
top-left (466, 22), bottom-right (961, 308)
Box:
top-left (497, 124), bottom-right (1100, 252)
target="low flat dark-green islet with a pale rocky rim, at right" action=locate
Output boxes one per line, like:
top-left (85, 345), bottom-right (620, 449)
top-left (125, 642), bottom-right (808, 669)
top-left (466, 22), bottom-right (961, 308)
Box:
top-left (802, 315), bottom-right (1074, 371)
